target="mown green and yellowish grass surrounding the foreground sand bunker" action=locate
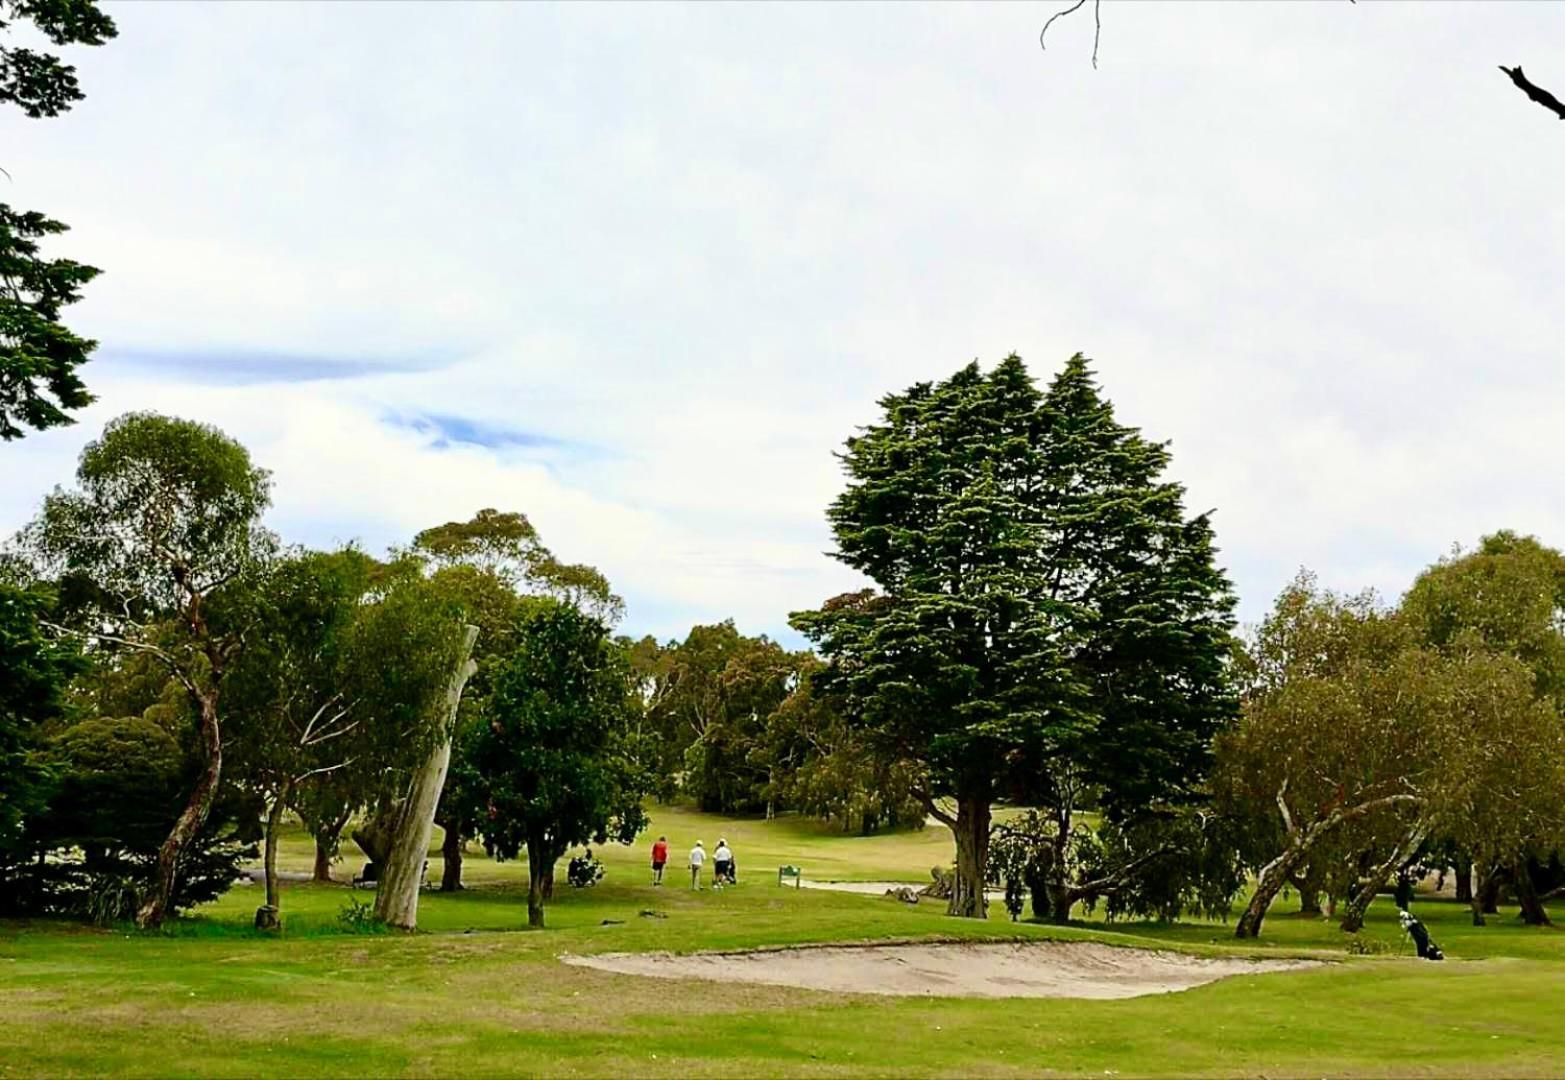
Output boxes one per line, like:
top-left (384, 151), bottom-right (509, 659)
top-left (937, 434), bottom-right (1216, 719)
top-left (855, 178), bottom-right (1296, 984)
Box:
top-left (0, 808), bottom-right (1565, 1077)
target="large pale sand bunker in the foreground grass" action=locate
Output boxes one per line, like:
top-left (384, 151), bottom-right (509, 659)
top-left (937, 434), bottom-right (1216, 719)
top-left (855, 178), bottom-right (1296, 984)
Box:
top-left (562, 941), bottom-right (1319, 999)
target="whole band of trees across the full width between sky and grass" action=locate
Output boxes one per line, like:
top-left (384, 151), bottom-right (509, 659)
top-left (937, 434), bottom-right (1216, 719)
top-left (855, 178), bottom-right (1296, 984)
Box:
top-left (0, 355), bottom-right (1565, 936)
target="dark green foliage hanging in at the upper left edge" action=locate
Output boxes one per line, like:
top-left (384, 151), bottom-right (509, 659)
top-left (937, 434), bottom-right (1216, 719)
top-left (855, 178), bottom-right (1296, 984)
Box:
top-left (0, 0), bottom-right (116, 440)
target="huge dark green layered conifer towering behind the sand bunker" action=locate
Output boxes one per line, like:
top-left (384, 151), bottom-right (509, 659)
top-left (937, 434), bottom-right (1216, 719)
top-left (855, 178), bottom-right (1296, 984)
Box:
top-left (792, 355), bottom-right (1233, 917)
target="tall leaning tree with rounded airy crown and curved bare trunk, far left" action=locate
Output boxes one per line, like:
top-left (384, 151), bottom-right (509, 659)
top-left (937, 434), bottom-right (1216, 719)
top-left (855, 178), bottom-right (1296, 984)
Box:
top-left (23, 413), bottom-right (275, 927)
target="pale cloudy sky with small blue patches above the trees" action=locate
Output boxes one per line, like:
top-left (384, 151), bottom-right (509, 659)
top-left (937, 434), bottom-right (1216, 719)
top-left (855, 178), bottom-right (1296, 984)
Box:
top-left (0, 0), bottom-right (1565, 643)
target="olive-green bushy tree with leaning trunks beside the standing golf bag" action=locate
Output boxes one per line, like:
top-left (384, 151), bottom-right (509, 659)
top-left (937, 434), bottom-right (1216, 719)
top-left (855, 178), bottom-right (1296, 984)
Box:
top-left (1219, 574), bottom-right (1565, 938)
